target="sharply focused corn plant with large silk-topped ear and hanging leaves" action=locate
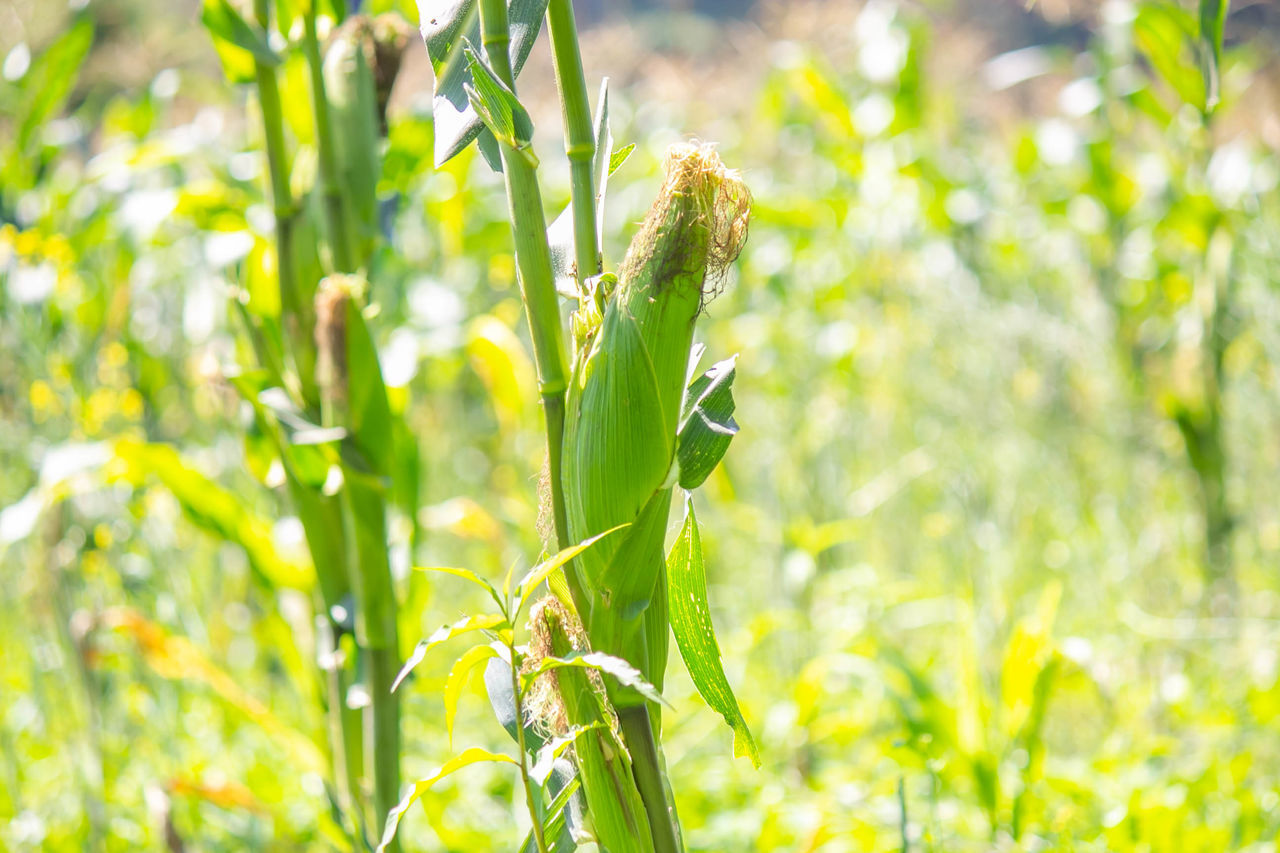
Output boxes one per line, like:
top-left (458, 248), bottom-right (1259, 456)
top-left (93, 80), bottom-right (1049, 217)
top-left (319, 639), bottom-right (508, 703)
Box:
top-left (383, 0), bottom-right (758, 853)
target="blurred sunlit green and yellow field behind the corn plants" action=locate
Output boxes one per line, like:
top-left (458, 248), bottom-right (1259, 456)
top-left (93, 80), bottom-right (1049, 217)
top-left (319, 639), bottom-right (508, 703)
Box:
top-left (0, 0), bottom-right (1280, 852)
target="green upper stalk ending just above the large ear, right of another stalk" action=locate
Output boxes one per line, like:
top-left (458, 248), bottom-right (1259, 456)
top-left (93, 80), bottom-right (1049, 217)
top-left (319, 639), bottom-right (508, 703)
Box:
top-left (547, 0), bottom-right (600, 281)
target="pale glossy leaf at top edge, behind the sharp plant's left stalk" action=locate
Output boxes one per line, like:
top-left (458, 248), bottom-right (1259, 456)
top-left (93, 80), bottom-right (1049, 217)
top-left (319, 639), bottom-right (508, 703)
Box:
top-left (417, 0), bottom-right (547, 167)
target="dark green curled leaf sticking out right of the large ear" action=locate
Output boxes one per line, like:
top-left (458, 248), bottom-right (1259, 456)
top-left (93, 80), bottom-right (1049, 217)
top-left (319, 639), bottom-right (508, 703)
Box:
top-left (676, 356), bottom-right (737, 489)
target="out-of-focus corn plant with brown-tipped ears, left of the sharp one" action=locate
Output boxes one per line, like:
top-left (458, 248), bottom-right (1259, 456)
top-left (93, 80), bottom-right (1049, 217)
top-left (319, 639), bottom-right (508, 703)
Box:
top-left (192, 0), bottom-right (416, 848)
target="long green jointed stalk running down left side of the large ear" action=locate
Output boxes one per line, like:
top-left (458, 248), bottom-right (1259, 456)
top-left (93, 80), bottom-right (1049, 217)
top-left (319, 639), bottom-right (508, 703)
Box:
top-left (480, 0), bottom-right (588, 612)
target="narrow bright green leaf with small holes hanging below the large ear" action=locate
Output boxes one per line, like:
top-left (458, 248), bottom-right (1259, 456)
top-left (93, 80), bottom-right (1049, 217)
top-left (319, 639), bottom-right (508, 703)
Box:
top-left (667, 498), bottom-right (760, 767)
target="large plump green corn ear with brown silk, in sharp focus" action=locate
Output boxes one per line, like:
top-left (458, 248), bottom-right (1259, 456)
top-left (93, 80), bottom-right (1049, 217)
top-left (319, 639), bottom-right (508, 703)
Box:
top-left (562, 145), bottom-right (750, 707)
